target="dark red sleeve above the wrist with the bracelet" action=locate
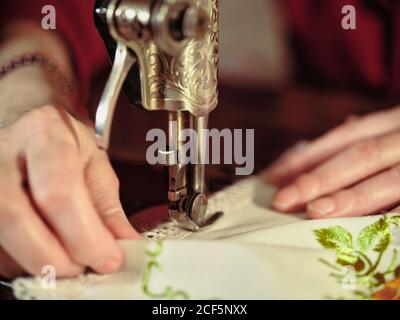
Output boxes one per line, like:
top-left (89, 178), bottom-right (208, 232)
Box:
top-left (0, 0), bottom-right (107, 114)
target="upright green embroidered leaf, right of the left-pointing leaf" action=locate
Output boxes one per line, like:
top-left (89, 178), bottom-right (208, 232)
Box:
top-left (357, 217), bottom-right (392, 252)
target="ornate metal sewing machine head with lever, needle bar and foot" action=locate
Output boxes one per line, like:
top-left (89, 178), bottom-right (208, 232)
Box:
top-left (95, 0), bottom-right (218, 230)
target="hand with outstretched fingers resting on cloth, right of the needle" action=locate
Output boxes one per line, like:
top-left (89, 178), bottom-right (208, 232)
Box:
top-left (266, 107), bottom-right (400, 218)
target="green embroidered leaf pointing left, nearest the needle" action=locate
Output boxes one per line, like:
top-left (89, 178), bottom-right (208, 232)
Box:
top-left (314, 226), bottom-right (353, 252)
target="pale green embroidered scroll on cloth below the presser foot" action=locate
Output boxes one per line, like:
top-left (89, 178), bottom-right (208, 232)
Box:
top-left (142, 241), bottom-right (190, 300)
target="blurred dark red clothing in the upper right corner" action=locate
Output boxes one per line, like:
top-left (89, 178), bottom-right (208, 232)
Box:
top-left (287, 0), bottom-right (400, 97)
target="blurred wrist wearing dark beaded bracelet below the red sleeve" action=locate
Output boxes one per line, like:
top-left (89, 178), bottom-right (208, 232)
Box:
top-left (0, 23), bottom-right (78, 125)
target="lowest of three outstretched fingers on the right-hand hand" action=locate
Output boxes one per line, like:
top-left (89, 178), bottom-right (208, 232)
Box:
top-left (307, 165), bottom-right (400, 218)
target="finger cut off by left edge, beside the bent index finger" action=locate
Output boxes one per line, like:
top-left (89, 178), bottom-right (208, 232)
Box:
top-left (0, 185), bottom-right (83, 277)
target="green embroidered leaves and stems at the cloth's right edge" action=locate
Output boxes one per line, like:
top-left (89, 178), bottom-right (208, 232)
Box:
top-left (314, 216), bottom-right (400, 299)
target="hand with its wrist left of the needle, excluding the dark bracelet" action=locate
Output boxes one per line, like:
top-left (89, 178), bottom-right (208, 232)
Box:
top-left (0, 22), bottom-right (139, 278)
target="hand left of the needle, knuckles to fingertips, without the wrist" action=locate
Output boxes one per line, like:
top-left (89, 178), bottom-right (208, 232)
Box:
top-left (0, 106), bottom-right (139, 277)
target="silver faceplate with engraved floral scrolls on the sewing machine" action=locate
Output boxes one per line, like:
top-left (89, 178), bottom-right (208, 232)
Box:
top-left (144, 0), bottom-right (218, 116)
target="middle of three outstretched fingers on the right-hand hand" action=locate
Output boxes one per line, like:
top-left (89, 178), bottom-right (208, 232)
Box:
top-left (273, 132), bottom-right (400, 211)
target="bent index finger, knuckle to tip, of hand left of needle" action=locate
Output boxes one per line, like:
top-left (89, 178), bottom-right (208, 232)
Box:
top-left (26, 111), bottom-right (123, 273)
